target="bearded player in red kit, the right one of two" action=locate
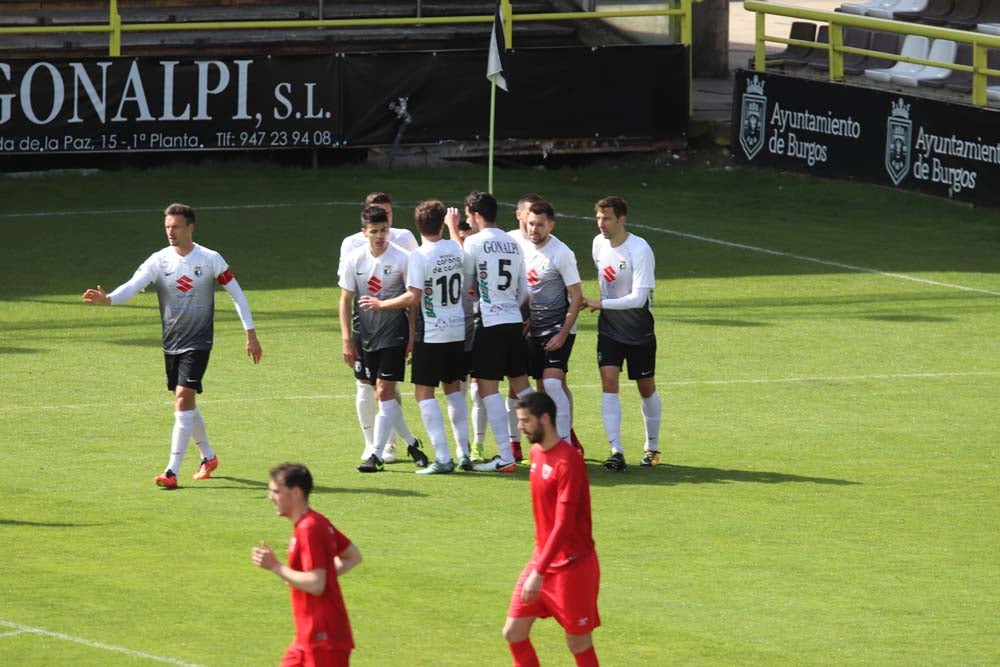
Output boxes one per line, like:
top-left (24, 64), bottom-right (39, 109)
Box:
top-left (503, 392), bottom-right (601, 667)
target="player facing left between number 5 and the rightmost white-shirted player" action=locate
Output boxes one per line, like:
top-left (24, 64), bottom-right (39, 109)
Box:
top-left (524, 201), bottom-right (583, 441)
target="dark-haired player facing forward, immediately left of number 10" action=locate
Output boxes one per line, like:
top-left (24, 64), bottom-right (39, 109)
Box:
top-left (340, 206), bottom-right (427, 472)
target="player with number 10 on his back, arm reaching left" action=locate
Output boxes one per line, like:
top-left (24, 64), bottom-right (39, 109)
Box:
top-left (359, 200), bottom-right (472, 474)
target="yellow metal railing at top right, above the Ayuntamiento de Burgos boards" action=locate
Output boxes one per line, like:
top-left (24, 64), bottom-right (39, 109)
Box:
top-left (743, 0), bottom-right (1000, 106)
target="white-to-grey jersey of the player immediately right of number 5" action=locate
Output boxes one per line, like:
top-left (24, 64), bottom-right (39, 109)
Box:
top-left (524, 234), bottom-right (580, 338)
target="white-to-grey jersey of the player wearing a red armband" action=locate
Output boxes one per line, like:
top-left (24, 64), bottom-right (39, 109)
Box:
top-left (111, 243), bottom-right (231, 354)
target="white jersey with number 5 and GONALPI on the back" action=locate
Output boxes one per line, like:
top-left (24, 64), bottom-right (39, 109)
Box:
top-left (465, 227), bottom-right (528, 327)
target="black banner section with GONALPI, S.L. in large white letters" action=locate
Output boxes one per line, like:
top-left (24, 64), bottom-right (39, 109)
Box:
top-left (0, 56), bottom-right (339, 155)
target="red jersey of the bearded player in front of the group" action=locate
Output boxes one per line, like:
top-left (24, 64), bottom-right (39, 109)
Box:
top-left (529, 440), bottom-right (594, 574)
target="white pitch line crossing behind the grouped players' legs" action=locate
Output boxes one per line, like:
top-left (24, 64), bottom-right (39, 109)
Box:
top-left (5, 371), bottom-right (1000, 412)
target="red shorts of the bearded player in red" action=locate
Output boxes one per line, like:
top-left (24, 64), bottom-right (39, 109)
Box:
top-left (507, 552), bottom-right (601, 635)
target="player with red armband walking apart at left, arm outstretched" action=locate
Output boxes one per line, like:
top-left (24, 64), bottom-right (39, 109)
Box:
top-left (83, 204), bottom-right (261, 489)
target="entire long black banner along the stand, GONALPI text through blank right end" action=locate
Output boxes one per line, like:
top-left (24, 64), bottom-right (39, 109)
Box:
top-left (0, 45), bottom-right (688, 156)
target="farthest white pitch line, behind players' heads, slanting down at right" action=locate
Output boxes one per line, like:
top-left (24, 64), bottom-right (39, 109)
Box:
top-left (0, 201), bottom-right (1000, 296)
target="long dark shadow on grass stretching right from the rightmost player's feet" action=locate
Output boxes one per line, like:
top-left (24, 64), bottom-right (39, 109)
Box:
top-left (587, 460), bottom-right (861, 486)
